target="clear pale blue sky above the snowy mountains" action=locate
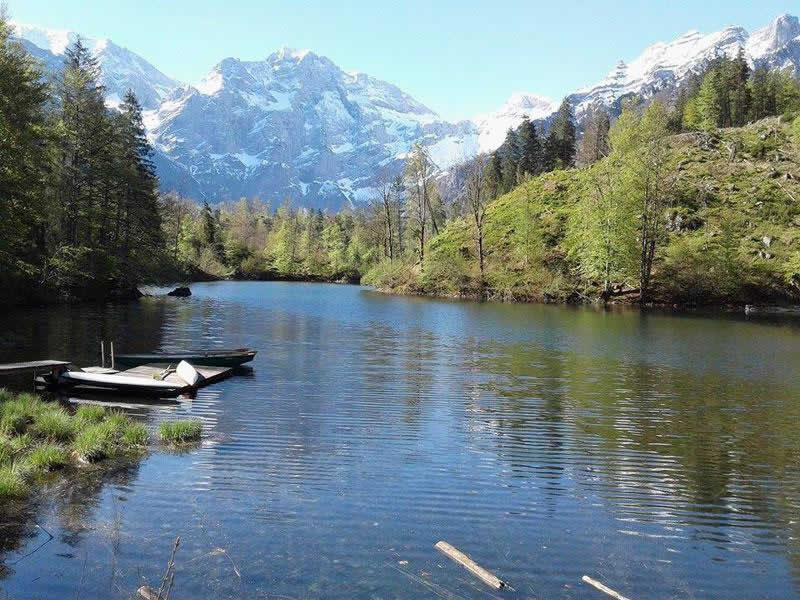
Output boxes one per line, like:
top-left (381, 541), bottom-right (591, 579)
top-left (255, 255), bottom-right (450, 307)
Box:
top-left (8, 0), bottom-right (800, 119)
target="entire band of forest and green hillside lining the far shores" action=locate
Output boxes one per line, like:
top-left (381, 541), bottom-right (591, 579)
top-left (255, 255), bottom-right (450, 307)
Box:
top-left (0, 11), bottom-right (800, 304)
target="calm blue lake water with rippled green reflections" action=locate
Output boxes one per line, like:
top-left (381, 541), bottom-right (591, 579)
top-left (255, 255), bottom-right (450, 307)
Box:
top-left (0, 283), bottom-right (800, 600)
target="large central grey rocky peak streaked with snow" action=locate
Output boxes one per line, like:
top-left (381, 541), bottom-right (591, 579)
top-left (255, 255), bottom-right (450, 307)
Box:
top-left (146, 48), bottom-right (477, 208)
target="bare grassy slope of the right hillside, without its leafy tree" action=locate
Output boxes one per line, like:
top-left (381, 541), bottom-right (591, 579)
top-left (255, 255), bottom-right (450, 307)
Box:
top-left (364, 118), bottom-right (800, 304)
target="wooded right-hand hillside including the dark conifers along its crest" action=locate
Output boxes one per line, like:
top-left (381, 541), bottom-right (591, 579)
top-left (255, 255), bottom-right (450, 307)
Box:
top-left (365, 52), bottom-right (800, 303)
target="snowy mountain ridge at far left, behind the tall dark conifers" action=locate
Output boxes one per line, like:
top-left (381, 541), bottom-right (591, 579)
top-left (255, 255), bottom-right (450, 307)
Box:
top-left (12, 23), bottom-right (181, 109)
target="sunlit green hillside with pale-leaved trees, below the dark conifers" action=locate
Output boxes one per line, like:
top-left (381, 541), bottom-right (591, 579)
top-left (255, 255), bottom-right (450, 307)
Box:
top-left (372, 115), bottom-right (800, 304)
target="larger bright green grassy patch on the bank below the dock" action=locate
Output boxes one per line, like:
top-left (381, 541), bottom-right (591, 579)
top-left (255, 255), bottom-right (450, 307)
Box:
top-left (0, 389), bottom-right (148, 499)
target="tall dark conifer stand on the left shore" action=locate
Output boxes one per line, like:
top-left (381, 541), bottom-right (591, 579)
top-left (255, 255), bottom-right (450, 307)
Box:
top-left (0, 18), bottom-right (163, 302)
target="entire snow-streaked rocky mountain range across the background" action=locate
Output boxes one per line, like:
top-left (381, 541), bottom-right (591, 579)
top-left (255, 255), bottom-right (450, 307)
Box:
top-left (17, 15), bottom-right (800, 209)
